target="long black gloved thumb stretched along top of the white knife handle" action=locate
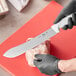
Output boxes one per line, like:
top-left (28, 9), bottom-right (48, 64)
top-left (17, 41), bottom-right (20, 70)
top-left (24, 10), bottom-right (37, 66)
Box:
top-left (54, 2), bottom-right (76, 24)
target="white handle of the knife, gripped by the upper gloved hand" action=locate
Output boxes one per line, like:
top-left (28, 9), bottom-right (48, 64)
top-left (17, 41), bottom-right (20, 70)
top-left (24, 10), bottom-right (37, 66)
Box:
top-left (51, 14), bottom-right (72, 33)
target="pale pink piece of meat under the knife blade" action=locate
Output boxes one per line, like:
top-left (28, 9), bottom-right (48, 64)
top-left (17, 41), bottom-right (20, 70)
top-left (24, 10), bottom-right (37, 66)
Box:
top-left (25, 38), bottom-right (50, 67)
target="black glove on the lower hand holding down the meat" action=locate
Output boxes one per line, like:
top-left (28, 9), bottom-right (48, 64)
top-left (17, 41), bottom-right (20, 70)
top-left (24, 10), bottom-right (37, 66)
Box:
top-left (34, 54), bottom-right (61, 75)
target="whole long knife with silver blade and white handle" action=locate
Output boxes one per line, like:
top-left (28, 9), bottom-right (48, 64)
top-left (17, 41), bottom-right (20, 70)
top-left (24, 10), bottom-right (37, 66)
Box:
top-left (3, 15), bottom-right (72, 58)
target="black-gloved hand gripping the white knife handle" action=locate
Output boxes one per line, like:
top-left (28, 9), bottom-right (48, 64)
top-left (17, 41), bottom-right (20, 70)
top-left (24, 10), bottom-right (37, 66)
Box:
top-left (54, 0), bottom-right (76, 30)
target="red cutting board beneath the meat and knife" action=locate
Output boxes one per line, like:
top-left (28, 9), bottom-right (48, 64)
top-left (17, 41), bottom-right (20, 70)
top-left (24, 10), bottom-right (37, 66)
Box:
top-left (0, 1), bottom-right (76, 76)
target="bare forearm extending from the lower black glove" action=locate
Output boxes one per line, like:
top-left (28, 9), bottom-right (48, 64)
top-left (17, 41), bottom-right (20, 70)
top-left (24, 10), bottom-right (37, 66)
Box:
top-left (58, 58), bottom-right (76, 72)
